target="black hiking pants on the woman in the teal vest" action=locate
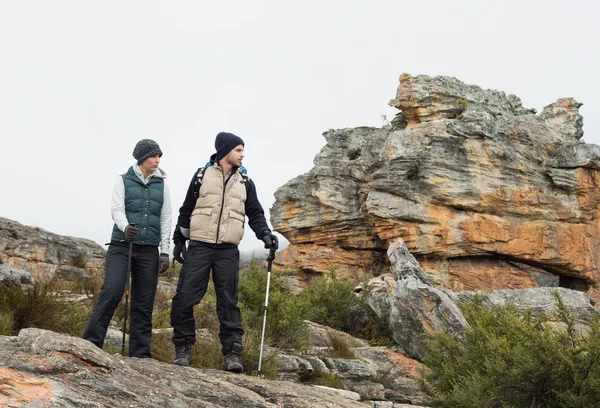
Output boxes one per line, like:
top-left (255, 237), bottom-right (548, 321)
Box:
top-left (83, 242), bottom-right (158, 357)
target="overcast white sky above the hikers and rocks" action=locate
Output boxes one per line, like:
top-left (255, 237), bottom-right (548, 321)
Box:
top-left (0, 0), bottom-right (600, 256)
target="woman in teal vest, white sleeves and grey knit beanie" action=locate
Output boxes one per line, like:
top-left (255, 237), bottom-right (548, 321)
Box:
top-left (83, 139), bottom-right (172, 357)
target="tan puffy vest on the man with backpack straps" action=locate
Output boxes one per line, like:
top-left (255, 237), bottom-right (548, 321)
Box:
top-left (190, 164), bottom-right (246, 245)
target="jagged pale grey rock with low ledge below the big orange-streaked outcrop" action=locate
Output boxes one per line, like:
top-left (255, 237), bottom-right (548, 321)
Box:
top-left (367, 239), bottom-right (599, 359)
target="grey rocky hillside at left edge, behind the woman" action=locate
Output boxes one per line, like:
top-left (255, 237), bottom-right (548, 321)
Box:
top-left (0, 217), bottom-right (106, 280)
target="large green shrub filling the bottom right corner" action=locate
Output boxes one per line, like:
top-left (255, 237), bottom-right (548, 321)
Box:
top-left (422, 292), bottom-right (600, 408)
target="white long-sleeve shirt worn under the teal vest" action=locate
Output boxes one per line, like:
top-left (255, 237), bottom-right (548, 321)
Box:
top-left (110, 164), bottom-right (173, 254)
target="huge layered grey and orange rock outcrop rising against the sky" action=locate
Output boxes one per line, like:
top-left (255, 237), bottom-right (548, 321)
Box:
top-left (271, 74), bottom-right (600, 300)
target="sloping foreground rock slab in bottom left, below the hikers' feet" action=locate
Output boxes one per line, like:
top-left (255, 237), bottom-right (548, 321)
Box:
top-left (0, 329), bottom-right (404, 408)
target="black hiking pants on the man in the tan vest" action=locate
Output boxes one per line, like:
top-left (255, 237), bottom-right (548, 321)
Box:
top-left (171, 241), bottom-right (244, 354)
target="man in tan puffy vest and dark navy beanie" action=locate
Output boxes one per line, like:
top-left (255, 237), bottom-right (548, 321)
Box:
top-left (171, 132), bottom-right (278, 373)
